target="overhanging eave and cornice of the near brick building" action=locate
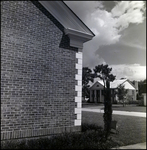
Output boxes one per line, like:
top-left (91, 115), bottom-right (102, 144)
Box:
top-left (39, 1), bottom-right (95, 47)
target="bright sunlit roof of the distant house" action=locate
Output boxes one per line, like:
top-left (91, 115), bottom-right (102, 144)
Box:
top-left (89, 78), bottom-right (135, 90)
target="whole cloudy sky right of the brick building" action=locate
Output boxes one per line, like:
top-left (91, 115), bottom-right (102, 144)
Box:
top-left (64, 1), bottom-right (146, 81)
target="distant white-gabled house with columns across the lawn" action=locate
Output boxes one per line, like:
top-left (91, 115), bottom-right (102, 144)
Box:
top-left (89, 78), bottom-right (138, 103)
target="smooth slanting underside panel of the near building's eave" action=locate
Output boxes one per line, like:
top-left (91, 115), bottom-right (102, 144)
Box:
top-left (38, 1), bottom-right (95, 37)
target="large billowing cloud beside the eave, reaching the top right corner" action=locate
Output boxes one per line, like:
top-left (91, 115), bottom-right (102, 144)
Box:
top-left (83, 1), bottom-right (144, 70)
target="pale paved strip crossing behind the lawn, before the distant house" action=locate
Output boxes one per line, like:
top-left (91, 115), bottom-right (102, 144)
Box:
top-left (82, 107), bottom-right (146, 117)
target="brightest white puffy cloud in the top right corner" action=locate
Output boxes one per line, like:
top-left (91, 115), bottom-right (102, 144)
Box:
top-left (111, 1), bottom-right (145, 32)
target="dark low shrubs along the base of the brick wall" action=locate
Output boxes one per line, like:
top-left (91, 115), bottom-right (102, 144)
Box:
top-left (1, 124), bottom-right (120, 150)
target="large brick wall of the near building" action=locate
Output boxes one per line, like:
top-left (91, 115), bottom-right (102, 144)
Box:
top-left (1, 1), bottom-right (80, 140)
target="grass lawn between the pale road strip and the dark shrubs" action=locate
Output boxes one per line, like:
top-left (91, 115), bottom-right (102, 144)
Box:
top-left (82, 111), bottom-right (146, 146)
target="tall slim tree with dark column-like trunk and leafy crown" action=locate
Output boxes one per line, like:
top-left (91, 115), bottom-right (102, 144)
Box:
top-left (93, 64), bottom-right (116, 140)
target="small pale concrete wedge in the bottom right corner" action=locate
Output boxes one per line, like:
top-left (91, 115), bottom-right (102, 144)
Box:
top-left (112, 142), bottom-right (146, 149)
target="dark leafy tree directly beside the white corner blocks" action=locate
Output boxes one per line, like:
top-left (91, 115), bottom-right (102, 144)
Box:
top-left (82, 67), bottom-right (94, 100)
